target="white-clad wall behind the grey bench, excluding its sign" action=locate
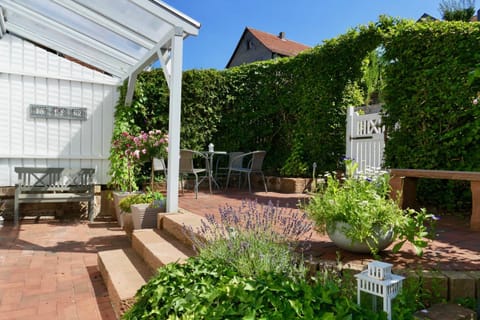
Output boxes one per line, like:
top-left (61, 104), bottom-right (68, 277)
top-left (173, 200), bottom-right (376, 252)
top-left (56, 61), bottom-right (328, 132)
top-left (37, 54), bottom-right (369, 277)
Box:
top-left (0, 34), bottom-right (118, 186)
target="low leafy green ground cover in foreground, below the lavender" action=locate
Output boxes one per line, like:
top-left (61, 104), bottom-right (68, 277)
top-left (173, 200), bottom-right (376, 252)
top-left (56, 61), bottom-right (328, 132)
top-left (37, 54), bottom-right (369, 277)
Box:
top-left (123, 257), bottom-right (386, 320)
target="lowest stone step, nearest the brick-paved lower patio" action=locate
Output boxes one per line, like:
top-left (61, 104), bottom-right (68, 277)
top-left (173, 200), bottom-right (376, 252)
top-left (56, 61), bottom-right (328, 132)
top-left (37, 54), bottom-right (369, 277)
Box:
top-left (97, 248), bottom-right (153, 319)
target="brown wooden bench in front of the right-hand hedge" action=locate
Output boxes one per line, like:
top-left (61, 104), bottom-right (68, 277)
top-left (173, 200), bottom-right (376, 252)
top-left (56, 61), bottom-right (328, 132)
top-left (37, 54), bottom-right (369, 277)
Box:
top-left (390, 169), bottom-right (480, 231)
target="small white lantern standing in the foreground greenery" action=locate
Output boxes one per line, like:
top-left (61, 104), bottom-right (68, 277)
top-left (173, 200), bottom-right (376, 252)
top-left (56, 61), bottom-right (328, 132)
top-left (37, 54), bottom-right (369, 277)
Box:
top-left (355, 261), bottom-right (405, 320)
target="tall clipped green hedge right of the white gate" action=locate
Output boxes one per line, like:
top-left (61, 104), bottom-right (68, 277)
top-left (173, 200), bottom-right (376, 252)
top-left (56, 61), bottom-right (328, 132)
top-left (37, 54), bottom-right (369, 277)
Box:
top-left (383, 22), bottom-right (480, 208)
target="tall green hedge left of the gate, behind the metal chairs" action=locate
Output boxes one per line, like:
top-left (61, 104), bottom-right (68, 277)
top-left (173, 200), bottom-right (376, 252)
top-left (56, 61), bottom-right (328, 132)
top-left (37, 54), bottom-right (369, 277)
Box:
top-left (109, 25), bottom-right (381, 185)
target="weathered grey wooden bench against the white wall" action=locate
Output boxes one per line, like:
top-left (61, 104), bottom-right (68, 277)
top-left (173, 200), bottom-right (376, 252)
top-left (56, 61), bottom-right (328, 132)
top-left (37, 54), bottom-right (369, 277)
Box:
top-left (14, 167), bottom-right (95, 226)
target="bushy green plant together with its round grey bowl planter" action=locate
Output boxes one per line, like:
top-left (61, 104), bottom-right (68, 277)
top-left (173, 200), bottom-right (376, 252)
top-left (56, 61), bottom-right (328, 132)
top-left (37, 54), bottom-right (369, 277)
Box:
top-left (304, 160), bottom-right (434, 255)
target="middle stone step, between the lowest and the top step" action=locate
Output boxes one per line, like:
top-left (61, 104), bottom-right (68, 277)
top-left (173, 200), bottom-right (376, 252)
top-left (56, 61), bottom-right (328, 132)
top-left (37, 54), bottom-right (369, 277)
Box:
top-left (132, 229), bottom-right (195, 272)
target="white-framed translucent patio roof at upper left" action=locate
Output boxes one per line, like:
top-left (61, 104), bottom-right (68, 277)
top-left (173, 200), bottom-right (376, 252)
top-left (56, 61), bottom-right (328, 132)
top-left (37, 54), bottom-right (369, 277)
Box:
top-left (0, 0), bottom-right (200, 80)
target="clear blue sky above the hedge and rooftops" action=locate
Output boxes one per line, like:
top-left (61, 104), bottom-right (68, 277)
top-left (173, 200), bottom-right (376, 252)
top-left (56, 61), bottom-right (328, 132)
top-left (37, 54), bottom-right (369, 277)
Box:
top-left (163, 0), bottom-right (452, 70)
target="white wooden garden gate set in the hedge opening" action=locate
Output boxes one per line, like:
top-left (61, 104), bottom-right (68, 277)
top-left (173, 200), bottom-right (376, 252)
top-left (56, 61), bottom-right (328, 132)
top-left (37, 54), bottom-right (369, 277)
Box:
top-left (346, 106), bottom-right (385, 171)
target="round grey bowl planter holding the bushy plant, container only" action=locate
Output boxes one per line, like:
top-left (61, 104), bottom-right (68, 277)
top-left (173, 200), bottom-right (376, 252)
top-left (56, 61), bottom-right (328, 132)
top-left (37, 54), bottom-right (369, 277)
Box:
top-left (327, 221), bottom-right (394, 253)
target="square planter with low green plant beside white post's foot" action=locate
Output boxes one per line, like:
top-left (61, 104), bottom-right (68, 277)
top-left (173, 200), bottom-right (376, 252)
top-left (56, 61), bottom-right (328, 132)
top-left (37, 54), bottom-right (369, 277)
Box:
top-left (120, 190), bottom-right (166, 233)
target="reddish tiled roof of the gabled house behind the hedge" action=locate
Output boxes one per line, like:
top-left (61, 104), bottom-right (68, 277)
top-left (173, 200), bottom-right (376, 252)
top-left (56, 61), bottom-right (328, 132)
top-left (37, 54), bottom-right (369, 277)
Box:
top-left (227, 27), bottom-right (310, 68)
